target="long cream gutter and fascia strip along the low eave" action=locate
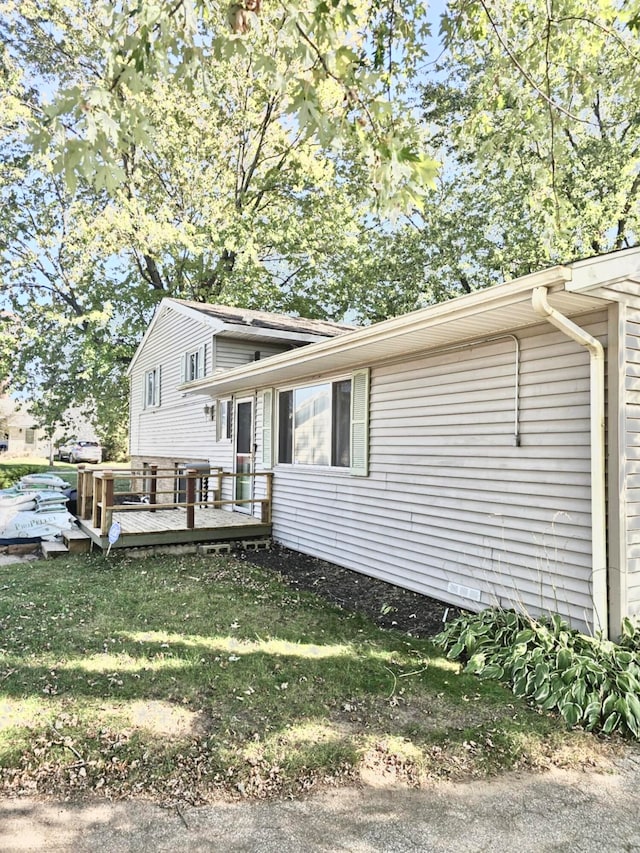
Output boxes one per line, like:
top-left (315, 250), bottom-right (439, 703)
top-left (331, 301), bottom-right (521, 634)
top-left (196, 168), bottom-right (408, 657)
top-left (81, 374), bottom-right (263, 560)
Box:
top-left (181, 266), bottom-right (570, 396)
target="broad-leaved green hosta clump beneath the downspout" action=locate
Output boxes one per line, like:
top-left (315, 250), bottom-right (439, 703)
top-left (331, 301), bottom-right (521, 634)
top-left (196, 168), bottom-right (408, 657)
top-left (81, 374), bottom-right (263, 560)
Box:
top-left (435, 609), bottom-right (640, 739)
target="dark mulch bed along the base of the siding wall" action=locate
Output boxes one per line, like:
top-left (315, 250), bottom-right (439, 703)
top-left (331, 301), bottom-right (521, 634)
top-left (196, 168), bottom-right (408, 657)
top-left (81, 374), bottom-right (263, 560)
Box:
top-left (236, 545), bottom-right (461, 637)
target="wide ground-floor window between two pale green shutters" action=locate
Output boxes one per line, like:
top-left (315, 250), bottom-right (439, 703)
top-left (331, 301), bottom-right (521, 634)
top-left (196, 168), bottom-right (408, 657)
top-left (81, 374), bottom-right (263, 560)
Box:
top-left (278, 379), bottom-right (351, 468)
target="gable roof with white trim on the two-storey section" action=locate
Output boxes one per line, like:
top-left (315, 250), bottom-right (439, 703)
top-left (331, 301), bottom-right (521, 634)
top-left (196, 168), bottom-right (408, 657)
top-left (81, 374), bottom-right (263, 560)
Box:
top-left (127, 297), bottom-right (356, 373)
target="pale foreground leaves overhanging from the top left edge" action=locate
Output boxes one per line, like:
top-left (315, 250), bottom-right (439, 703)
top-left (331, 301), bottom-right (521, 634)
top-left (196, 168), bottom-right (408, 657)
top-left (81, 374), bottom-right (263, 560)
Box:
top-left (21, 0), bottom-right (434, 207)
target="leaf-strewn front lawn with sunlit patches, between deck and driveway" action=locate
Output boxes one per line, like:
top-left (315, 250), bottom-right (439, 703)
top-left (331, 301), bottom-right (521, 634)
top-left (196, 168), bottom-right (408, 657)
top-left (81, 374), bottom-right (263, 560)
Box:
top-left (0, 555), bottom-right (624, 802)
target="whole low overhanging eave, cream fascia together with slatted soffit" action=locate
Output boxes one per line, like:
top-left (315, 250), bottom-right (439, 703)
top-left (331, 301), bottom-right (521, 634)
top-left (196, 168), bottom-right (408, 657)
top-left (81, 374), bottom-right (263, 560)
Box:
top-left (185, 243), bottom-right (640, 396)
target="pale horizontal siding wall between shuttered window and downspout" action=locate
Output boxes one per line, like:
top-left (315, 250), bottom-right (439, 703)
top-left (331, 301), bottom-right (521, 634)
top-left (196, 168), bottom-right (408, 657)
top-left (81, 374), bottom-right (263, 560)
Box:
top-left (258, 311), bottom-right (607, 627)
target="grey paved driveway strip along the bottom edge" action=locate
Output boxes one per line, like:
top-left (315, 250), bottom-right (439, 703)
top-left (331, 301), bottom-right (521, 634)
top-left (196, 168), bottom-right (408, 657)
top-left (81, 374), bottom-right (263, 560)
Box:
top-left (0, 751), bottom-right (640, 853)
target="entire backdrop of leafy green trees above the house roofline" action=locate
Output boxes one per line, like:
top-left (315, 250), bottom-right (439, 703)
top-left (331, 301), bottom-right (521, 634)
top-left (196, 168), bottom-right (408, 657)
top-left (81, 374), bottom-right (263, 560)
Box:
top-left (0, 0), bottom-right (640, 452)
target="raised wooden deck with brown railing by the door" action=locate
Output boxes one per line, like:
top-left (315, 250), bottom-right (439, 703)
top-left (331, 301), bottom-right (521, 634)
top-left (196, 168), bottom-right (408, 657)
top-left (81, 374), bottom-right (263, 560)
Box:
top-left (78, 469), bottom-right (271, 550)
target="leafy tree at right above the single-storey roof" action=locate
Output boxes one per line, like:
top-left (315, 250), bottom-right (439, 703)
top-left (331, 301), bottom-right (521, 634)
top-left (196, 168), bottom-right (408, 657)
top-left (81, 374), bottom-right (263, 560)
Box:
top-left (424, 0), bottom-right (640, 284)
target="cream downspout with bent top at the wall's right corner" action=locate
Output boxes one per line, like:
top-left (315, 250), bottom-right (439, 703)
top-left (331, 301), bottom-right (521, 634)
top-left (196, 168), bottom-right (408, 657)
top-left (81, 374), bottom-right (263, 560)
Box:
top-left (531, 287), bottom-right (609, 639)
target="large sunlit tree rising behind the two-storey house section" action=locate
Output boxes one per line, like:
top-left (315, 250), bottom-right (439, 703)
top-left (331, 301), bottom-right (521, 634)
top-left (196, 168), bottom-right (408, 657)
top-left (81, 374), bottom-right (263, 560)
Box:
top-left (1, 2), bottom-right (436, 450)
